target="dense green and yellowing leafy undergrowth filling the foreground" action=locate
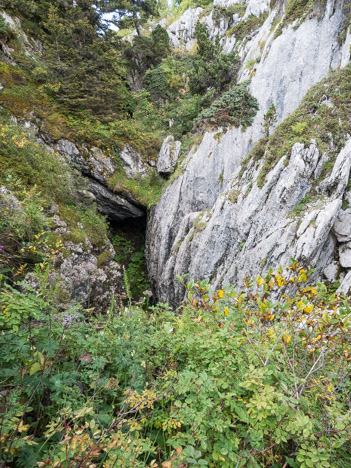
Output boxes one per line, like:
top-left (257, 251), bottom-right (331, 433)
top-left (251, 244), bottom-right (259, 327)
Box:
top-left (0, 263), bottom-right (351, 468)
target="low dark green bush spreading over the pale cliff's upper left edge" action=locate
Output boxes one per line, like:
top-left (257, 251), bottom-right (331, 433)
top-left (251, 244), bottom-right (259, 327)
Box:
top-left (199, 82), bottom-right (258, 128)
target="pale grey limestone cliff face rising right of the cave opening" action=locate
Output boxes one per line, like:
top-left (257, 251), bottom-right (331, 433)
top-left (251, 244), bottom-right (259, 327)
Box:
top-left (147, 0), bottom-right (351, 305)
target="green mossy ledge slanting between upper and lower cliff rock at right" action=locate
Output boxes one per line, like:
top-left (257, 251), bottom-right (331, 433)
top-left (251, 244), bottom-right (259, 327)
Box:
top-left (241, 65), bottom-right (351, 187)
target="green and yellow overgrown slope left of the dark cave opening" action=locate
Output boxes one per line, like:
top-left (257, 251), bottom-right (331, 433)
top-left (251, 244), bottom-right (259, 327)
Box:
top-left (0, 113), bottom-right (107, 278)
